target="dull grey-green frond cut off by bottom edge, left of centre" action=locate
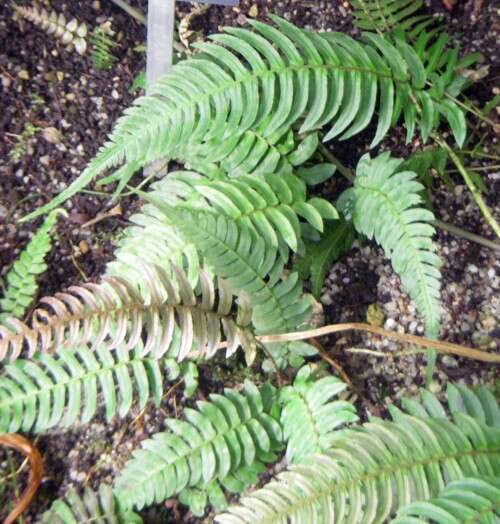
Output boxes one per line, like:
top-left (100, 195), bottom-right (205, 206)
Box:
top-left (38, 484), bottom-right (142, 524)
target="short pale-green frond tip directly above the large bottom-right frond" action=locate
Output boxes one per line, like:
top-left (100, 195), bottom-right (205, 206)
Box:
top-left (280, 366), bottom-right (358, 464)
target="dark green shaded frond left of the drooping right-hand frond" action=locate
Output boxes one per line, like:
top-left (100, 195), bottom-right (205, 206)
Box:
top-left (294, 221), bottom-right (355, 300)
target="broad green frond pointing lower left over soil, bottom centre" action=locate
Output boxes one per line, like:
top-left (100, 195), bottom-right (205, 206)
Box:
top-left (115, 381), bottom-right (282, 509)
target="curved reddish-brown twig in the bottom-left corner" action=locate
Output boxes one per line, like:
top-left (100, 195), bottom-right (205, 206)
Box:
top-left (0, 433), bottom-right (43, 524)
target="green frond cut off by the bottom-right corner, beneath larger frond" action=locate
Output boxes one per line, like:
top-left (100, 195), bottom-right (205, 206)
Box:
top-left (391, 478), bottom-right (500, 524)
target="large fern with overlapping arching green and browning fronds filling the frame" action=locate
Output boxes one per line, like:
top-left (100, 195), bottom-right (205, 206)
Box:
top-left (0, 10), bottom-right (494, 523)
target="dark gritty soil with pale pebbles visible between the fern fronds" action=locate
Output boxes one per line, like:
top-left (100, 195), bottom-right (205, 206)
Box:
top-left (0, 0), bottom-right (500, 523)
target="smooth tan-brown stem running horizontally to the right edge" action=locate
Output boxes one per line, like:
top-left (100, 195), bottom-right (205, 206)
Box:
top-left (256, 322), bottom-right (500, 364)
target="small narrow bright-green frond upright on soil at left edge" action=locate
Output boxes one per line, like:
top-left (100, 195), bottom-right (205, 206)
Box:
top-left (0, 209), bottom-right (65, 323)
